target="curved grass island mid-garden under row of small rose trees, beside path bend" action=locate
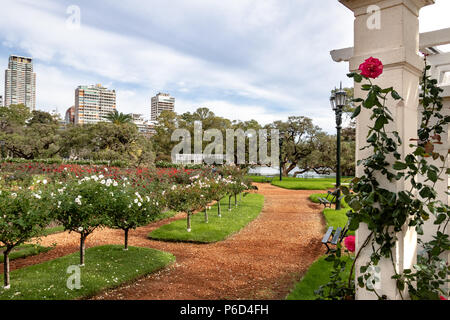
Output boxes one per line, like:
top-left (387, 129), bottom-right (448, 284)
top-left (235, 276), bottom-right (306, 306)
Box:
top-left (149, 193), bottom-right (264, 243)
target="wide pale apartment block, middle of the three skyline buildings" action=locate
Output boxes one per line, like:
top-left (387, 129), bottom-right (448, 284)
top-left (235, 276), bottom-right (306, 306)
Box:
top-left (75, 84), bottom-right (116, 125)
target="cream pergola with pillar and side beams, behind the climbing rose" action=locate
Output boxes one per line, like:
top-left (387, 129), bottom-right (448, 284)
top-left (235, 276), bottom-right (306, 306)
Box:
top-left (330, 0), bottom-right (450, 300)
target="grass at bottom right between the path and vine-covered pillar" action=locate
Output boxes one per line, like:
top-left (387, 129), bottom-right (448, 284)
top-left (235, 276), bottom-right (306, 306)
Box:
top-left (286, 256), bottom-right (353, 300)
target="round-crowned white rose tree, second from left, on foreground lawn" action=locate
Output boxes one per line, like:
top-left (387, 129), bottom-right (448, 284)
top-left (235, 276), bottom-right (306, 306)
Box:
top-left (54, 175), bottom-right (110, 266)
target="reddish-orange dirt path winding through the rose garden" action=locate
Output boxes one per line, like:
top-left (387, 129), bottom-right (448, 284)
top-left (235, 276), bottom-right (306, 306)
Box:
top-left (2, 184), bottom-right (324, 300)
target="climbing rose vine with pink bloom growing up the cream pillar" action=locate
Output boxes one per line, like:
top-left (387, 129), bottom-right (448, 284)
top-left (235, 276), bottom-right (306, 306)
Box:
top-left (316, 58), bottom-right (450, 299)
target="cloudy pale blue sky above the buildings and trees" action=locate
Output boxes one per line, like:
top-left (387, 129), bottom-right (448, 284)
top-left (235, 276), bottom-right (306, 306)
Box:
top-left (0, 0), bottom-right (450, 132)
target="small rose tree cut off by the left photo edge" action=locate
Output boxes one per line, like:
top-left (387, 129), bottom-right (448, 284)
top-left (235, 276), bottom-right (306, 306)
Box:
top-left (0, 188), bottom-right (51, 289)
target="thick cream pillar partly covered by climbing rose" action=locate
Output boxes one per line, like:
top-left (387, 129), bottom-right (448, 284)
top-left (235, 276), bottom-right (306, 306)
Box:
top-left (339, 0), bottom-right (434, 300)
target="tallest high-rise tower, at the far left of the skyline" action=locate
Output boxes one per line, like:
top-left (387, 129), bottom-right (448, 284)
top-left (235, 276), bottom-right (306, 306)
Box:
top-left (5, 55), bottom-right (36, 110)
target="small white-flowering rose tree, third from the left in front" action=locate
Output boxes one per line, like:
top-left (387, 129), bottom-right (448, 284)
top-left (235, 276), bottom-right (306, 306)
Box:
top-left (106, 186), bottom-right (161, 250)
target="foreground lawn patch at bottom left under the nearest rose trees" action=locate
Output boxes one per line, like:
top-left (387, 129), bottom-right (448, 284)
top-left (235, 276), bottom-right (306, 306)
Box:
top-left (0, 245), bottom-right (175, 300)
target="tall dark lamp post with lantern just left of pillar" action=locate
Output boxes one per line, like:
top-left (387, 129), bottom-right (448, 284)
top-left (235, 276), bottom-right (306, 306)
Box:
top-left (330, 82), bottom-right (347, 210)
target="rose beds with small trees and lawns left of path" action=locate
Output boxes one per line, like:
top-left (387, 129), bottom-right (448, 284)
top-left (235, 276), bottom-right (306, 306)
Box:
top-left (0, 161), bottom-right (264, 300)
